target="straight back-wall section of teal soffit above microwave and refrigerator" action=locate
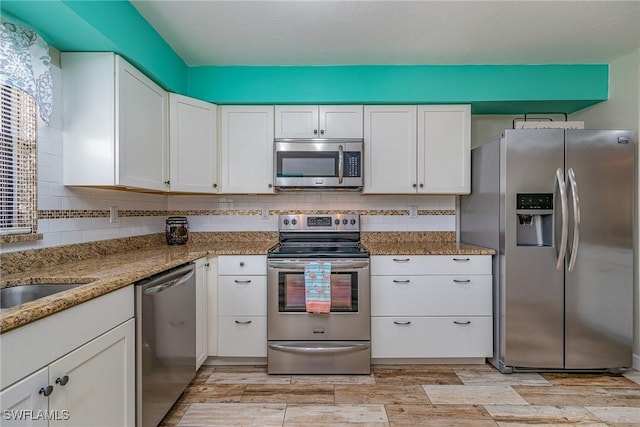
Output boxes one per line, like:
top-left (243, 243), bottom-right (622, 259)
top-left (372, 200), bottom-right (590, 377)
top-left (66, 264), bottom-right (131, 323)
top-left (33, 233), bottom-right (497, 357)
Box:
top-left (188, 64), bottom-right (609, 114)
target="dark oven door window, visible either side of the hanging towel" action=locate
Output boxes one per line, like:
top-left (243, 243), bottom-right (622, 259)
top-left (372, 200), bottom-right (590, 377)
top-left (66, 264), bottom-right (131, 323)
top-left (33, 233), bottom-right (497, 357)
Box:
top-left (278, 272), bottom-right (358, 313)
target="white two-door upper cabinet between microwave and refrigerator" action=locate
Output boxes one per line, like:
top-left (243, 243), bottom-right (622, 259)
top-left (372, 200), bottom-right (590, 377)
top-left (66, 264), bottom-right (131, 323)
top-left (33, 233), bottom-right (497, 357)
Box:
top-left (363, 105), bottom-right (471, 194)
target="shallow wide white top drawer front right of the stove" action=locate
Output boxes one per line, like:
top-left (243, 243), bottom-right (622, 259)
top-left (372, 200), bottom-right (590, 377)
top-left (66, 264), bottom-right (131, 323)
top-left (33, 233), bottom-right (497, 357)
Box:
top-left (371, 255), bottom-right (491, 275)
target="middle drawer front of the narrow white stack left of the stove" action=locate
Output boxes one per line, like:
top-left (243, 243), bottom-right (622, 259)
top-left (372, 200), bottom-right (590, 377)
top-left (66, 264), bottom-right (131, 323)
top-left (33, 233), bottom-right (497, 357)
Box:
top-left (218, 276), bottom-right (267, 316)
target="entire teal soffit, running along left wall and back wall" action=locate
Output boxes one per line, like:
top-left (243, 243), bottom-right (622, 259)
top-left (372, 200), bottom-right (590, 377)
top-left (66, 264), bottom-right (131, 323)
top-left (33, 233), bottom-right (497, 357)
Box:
top-left (0, 0), bottom-right (609, 114)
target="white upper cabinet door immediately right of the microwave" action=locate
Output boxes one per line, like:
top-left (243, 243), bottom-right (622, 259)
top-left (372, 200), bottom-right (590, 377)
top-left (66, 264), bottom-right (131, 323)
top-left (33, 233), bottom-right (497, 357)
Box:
top-left (363, 105), bottom-right (417, 193)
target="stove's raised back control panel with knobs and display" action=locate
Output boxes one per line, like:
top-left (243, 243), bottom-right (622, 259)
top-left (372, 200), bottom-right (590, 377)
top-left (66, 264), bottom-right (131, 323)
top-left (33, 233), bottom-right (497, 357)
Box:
top-left (278, 214), bottom-right (360, 232)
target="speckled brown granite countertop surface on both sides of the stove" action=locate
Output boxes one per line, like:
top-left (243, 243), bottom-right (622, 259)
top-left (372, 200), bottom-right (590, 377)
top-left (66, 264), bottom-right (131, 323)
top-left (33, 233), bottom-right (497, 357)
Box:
top-left (0, 240), bottom-right (495, 334)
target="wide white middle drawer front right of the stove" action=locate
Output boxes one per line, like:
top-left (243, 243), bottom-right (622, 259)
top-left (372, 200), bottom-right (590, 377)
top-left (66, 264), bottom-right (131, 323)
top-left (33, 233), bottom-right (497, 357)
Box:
top-left (371, 275), bottom-right (492, 316)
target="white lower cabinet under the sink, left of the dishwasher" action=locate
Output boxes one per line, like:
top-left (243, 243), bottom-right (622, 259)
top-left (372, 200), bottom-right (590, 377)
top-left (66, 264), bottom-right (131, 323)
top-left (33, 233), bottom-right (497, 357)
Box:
top-left (0, 286), bottom-right (135, 427)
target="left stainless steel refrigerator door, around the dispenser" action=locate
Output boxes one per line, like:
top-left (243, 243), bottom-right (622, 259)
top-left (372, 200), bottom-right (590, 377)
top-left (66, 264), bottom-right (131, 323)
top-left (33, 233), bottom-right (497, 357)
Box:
top-left (504, 129), bottom-right (564, 368)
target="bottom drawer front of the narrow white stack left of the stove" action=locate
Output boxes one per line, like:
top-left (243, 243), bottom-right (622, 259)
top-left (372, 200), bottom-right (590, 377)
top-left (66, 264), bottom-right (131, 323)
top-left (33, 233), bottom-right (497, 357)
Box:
top-left (218, 316), bottom-right (267, 357)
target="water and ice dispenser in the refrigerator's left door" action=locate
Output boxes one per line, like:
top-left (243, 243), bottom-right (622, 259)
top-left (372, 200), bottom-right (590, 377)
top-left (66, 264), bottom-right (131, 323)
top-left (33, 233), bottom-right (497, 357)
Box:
top-left (516, 193), bottom-right (553, 246)
